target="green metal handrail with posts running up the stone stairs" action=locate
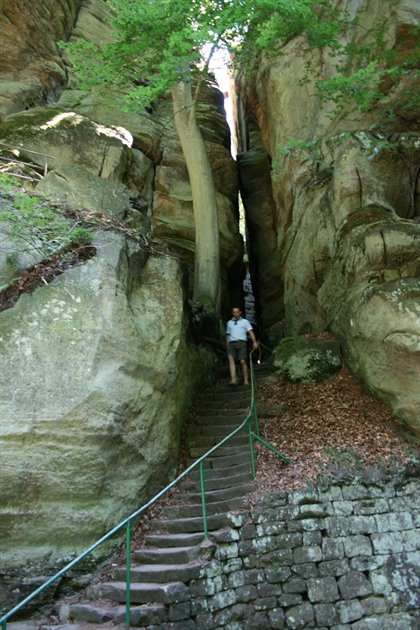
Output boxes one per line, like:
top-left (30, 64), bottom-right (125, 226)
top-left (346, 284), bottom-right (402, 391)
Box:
top-left (0, 344), bottom-right (292, 630)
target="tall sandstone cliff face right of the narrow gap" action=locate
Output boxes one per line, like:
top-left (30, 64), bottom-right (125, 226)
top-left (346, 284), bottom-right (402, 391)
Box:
top-left (238, 0), bottom-right (420, 431)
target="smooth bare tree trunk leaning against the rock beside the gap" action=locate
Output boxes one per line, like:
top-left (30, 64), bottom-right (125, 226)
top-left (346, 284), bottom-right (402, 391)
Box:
top-left (172, 81), bottom-right (220, 314)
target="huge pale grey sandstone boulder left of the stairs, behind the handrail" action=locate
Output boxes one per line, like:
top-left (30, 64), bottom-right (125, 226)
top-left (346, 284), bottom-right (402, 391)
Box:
top-left (0, 232), bottom-right (214, 607)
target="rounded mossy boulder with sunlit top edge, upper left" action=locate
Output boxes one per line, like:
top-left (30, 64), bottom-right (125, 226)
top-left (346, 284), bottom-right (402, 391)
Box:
top-left (0, 108), bottom-right (153, 233)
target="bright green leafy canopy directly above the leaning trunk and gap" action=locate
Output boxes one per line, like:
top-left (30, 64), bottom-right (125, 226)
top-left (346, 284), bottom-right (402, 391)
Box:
top-left (65, 0), bottom-right (349, 108)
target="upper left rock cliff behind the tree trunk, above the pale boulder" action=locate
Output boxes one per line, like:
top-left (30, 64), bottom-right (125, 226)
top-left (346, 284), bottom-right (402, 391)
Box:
top-left (0, 0), bottom-right (244, 315)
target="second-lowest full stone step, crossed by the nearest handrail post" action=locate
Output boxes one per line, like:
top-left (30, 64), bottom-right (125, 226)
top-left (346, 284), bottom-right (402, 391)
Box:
top-left (87, 581), bottom-right (189, 604)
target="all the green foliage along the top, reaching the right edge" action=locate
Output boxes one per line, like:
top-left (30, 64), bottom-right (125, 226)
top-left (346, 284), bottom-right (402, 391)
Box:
top-left (67, 0), bottom-right (420, 115)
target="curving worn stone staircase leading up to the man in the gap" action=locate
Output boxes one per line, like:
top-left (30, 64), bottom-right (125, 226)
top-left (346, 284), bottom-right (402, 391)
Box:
top-left (39, 366), bottom-right (264, 630)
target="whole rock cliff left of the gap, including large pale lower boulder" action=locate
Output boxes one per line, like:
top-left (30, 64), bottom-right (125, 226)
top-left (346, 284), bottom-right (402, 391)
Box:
top-left (0, 0), bottom-right (243, 607)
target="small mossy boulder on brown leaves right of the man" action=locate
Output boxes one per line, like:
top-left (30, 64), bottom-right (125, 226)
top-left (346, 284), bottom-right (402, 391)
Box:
top-left (273, 337), bottom-right (341, 383)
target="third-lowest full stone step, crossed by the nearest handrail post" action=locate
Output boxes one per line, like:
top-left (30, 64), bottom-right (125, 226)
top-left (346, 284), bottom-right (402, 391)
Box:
top-left (113, 560), bottom-right (205, 584)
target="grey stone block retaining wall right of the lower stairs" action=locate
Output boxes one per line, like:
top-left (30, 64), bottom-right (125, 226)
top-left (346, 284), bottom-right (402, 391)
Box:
top-left (189, 480), bottom-right (420, 630)
